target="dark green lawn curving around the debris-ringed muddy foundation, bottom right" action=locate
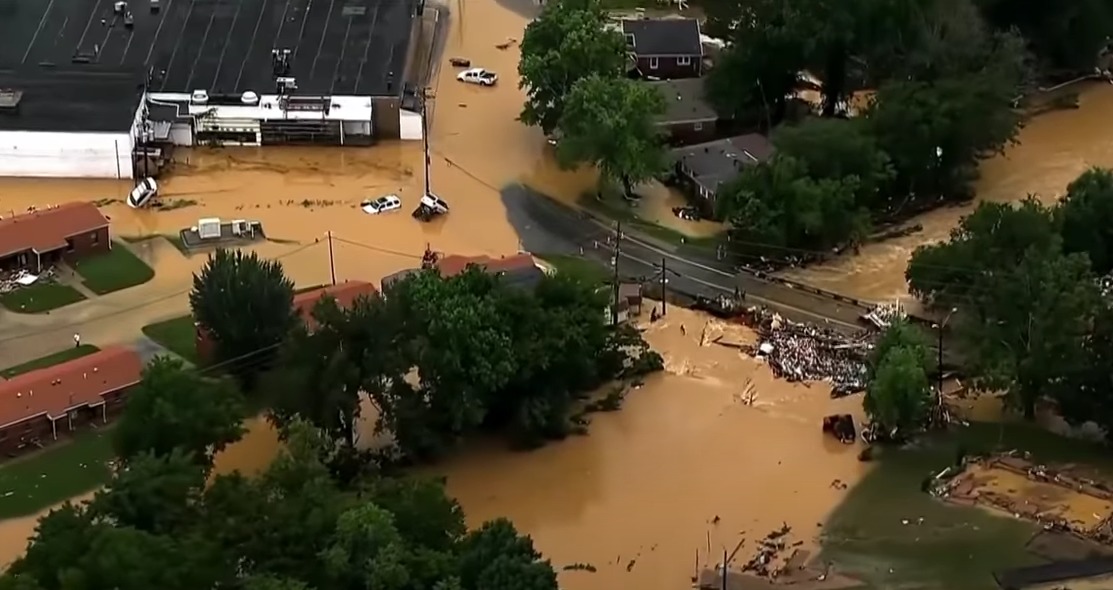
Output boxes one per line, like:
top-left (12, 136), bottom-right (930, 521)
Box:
top-left (821, 423), bottom-right (1113, 590)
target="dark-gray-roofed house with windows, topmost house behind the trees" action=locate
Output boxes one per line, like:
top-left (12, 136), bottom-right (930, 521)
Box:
top-left (622, 19), bottom-right (703, 80)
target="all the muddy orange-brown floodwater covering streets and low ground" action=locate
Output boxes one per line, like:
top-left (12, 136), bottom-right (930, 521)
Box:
top-left (0, 0), bottom-right (1113, 574)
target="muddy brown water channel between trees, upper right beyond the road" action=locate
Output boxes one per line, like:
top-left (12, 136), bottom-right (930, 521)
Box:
top-left (787, 82), bottom-right (1113, 302)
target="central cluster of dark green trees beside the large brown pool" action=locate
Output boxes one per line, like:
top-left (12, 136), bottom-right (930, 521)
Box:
top-left (264, 266), bottom-right (661, 460)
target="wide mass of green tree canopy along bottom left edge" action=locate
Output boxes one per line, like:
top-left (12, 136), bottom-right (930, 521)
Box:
top-left (0, 423), bottom-right (558, 590)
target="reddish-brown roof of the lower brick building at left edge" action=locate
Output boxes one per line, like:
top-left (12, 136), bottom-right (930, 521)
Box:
top-left (0, 346), bottom-right (142, 429)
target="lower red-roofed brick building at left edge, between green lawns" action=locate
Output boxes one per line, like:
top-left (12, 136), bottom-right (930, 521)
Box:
top-left (0, 346), bottom-right (142, 456)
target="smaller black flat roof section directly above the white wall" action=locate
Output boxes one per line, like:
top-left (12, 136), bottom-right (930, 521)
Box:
top-left (0, 67), bottom-right (142, 130)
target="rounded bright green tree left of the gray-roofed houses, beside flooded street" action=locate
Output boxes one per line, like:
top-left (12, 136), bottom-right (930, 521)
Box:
top-left (557, 76), bottom-right (666, 195)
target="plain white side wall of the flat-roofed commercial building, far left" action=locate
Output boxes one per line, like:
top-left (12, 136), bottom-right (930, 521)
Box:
top-left (0, 131), bottom-right (131, 178)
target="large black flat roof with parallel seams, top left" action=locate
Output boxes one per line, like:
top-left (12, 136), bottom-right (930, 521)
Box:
top-left (0, 0), bottom-right (416, 95)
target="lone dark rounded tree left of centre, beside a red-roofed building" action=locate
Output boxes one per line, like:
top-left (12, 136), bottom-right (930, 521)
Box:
top-left (189, 249), bottom-right (297, 376)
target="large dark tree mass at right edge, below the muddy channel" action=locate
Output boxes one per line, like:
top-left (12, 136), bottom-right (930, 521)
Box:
top-left (905, 170), bottom-right (1113, 425)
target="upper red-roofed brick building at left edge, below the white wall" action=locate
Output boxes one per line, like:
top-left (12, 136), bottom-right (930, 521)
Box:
top-left (0, 201), bottom-right (112, 273)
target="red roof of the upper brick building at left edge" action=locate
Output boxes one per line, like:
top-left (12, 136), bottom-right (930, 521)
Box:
top-left (0, 201), bottom-right (108, 256)
